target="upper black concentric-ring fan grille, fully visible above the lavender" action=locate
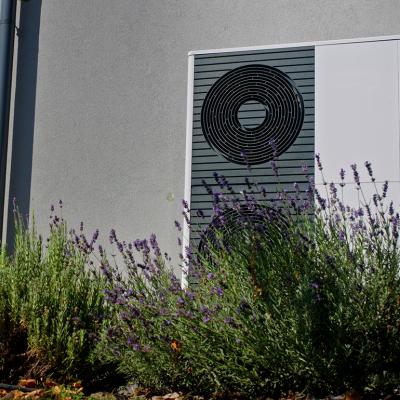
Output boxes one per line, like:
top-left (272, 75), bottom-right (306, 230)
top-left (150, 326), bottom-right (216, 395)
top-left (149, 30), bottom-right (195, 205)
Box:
top-left (201, 64), bottom-right (304, 165)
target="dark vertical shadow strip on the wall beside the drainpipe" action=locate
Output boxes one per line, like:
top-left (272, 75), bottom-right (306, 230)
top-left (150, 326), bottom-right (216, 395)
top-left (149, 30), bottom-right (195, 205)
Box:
top-left (7, 0), bottom-right (42, 250)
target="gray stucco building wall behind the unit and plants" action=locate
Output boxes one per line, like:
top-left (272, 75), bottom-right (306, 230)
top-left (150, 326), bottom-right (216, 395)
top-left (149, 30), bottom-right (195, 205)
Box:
top-left (4, 0), bottom-right (400, 268)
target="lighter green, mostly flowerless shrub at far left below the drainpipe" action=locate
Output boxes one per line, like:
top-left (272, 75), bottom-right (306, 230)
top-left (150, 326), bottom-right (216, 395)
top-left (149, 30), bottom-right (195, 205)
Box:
top-left (0, 203), bottom-right (108, 378)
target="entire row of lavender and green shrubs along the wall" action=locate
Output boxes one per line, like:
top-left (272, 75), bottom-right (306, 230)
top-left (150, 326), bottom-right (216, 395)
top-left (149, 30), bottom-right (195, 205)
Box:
top-left (0, 159), bottom-right (400, 398)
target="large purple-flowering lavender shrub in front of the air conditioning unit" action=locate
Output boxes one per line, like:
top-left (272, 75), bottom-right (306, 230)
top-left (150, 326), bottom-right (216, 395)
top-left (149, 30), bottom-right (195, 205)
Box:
top-left (98, 157), bottom-right (400, 396)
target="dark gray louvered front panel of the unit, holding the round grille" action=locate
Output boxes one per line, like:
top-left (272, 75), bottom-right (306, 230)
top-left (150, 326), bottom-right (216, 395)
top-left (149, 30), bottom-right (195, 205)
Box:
top-left (191, 47), bottom-right (314, 240)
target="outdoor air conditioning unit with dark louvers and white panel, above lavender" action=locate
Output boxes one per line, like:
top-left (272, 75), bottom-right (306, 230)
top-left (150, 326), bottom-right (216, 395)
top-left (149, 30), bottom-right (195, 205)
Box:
top-left (183, 37), bottom-right (400, 282)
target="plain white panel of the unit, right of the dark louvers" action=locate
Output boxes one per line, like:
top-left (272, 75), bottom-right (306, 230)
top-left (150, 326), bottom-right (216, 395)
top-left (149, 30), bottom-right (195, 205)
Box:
top-left (315, 40), bottom-right (400, 209)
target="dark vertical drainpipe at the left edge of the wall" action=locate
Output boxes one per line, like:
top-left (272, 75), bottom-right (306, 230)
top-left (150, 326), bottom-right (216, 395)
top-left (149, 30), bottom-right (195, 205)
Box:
top-left (0, 0), bottom-right (17, 243)
